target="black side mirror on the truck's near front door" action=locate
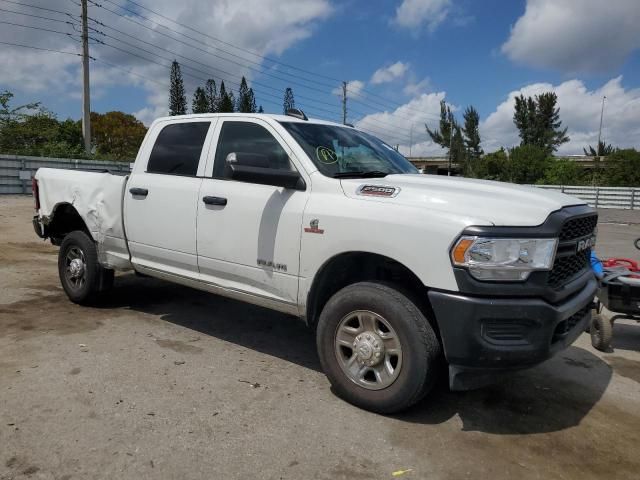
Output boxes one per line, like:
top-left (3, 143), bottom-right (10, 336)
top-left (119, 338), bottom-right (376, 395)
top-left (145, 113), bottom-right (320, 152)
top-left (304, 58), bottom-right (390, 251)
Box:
top-left (226, 152), bottom-right (307, 190)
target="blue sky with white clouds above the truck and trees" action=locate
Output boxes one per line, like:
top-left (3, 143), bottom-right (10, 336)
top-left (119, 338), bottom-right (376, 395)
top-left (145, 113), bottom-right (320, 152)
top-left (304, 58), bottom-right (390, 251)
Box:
top-left (0, 0), bottom-right (640, 156)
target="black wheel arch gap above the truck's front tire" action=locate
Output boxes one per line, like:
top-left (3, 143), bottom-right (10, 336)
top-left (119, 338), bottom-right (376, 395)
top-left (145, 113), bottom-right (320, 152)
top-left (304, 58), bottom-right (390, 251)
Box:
top-left (305, 251), bottom-right (439, 335)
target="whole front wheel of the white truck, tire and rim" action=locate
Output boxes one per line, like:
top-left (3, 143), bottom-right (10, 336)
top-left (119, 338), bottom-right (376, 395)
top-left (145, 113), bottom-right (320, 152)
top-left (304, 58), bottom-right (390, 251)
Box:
top-left (317, 282), bottom-right (441, 413)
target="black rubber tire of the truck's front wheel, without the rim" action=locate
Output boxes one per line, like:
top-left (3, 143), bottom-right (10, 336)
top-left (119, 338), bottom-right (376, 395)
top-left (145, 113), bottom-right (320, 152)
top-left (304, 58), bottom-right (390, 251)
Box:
top-left (316, 282), bottom-right (442, 414)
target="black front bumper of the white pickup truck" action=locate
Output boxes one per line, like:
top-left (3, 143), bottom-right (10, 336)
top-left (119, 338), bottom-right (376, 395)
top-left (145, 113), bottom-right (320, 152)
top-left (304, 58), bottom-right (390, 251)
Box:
top-left (429, 277), bottom-right (598, 390)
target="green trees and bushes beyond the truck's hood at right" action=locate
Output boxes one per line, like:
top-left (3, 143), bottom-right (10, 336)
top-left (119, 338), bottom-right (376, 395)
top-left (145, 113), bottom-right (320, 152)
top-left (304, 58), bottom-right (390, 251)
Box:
top-left (425, 92), bottom-right (640, 187)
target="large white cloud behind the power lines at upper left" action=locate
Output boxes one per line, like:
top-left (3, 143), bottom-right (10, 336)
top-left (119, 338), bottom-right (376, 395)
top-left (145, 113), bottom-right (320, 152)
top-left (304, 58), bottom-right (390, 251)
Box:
top-left (0, 0), bottom-right (333, 122)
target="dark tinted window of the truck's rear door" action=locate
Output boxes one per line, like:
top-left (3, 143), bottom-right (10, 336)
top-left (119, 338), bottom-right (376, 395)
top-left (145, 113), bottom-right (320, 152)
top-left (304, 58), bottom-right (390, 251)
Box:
top-left (147, 122), bottom-right (210, 176)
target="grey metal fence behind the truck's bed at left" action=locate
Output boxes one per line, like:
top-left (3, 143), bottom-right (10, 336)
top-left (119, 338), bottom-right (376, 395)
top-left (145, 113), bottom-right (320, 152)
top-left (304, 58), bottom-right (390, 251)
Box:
top-left (0, 155), bottom-right (131, 194)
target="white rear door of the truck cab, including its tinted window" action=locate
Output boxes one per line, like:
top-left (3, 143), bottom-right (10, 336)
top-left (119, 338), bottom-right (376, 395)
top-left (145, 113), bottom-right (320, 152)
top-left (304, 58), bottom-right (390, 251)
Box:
top-left (124, 119), bottom-right (211, 278)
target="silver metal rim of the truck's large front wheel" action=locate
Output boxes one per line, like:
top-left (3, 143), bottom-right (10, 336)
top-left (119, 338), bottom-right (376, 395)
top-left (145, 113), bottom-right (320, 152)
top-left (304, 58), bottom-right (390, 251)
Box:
top-left (334, 310), bottom-right (402, 390)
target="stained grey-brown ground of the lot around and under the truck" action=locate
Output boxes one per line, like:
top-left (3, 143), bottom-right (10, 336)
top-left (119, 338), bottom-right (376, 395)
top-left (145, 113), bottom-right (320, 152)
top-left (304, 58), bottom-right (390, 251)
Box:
top-left (0, 197), bottom-right (640, 480)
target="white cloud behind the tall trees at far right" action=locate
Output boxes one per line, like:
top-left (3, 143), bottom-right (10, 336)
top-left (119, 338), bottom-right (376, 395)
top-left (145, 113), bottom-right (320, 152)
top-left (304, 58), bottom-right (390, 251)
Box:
top-left (480, 77), bottom-right (640, 154)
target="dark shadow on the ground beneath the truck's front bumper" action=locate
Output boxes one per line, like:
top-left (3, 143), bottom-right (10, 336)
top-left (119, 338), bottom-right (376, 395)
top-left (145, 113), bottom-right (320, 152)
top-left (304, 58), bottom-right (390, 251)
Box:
top-left (396, 346), bottom-right (612, 435)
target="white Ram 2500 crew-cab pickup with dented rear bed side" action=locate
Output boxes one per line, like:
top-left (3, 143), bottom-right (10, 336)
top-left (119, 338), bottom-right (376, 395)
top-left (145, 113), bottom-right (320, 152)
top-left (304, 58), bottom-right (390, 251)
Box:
top-left (34, 111), bottom-right (597, 413)
